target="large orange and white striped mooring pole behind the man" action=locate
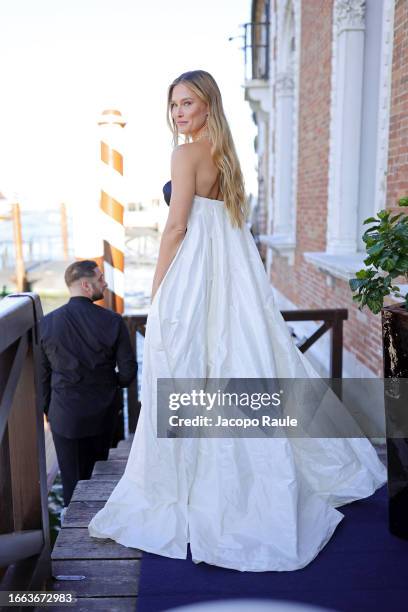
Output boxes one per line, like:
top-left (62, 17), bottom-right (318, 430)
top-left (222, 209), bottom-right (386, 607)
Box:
top-left (98, 110), bottom-right (126, 313)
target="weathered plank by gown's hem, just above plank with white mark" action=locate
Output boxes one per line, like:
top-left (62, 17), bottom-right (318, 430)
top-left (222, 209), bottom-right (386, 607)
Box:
top-left (51, 526), bottom-right (142, 560)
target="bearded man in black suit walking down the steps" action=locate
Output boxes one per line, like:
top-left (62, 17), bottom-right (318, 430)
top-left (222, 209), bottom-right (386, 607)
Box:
top-left (40, 260), bottom-right (137, 506)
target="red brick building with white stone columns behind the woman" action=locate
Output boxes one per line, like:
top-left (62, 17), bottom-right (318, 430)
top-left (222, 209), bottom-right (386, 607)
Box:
top-left (245, 0), bottom-right (408, 377)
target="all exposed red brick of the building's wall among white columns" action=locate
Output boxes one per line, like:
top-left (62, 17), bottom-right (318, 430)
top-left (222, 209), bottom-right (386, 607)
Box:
top-left (271, 0), bottom-right (398, 376)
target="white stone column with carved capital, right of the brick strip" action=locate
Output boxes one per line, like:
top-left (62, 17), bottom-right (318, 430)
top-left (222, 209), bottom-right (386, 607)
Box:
top-left (327, 0), bottom-right (365, 254)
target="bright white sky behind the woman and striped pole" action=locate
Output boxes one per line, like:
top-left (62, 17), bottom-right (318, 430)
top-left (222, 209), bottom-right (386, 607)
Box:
top-left (0, 0), bottom-right (256, 209)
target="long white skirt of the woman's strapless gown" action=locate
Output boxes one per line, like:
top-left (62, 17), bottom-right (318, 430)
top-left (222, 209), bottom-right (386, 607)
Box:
top-left (88, 196), bottom-right (386, 572)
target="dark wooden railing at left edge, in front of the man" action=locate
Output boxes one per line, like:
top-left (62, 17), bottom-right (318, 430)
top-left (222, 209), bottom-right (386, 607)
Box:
top-left (0, 293), bottom-right (51, 590)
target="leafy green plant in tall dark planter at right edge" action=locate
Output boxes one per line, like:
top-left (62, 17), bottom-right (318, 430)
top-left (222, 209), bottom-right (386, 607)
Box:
top-left (349, 198), bottom-right (408, 539)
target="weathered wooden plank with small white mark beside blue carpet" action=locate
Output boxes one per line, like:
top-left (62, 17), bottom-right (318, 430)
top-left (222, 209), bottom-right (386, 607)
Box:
top-left (50, 559), bottom-right (140, 596)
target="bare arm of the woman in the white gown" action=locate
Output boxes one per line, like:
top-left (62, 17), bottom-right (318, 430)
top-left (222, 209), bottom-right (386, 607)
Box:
top-left (152, 144), bottom-right (196, 300)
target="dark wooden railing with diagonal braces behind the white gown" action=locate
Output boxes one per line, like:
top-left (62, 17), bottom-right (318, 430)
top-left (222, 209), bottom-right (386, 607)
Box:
top-left (123, 308), bottom-right (348, 433)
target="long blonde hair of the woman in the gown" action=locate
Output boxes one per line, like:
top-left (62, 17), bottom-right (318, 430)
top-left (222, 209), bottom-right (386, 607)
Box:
top-left (167, 70), bottom-right (248, 227)
